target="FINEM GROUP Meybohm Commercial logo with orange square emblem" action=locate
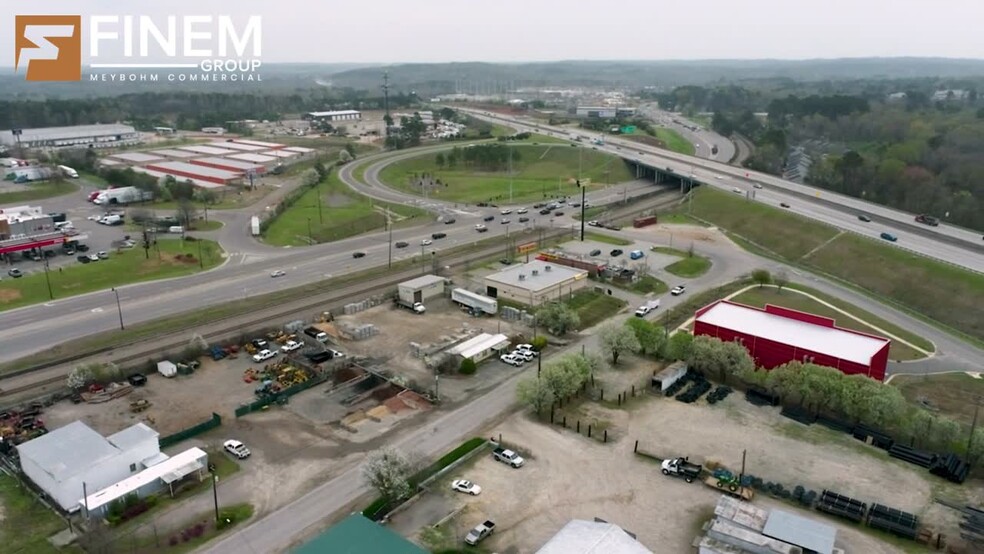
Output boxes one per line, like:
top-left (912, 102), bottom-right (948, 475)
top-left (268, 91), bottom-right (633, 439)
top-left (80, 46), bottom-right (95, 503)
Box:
top-left (14, 15), bottom-right (262, 82)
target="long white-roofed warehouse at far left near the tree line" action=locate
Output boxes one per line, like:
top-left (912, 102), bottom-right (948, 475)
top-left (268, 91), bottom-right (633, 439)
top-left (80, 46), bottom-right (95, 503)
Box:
top-left (0, 124), bottom-right (140, 148)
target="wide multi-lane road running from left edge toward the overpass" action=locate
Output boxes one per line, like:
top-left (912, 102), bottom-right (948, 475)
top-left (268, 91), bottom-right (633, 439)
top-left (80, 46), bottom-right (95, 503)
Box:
top-left (0, 221), bottom-right (534, 362)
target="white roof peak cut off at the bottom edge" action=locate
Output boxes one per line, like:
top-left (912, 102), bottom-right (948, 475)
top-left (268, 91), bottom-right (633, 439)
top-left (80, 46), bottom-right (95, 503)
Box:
top-left (536, 518), bottom-right (653, 554)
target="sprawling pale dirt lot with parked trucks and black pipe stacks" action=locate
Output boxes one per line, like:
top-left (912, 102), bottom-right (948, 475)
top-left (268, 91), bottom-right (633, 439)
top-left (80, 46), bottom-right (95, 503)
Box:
top-left (394, 356), bottom-right (984, 554)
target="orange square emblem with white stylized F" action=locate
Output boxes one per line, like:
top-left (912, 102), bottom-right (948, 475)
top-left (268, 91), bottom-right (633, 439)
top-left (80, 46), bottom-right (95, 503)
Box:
top-left (14, 15), bottom-right (82, 81)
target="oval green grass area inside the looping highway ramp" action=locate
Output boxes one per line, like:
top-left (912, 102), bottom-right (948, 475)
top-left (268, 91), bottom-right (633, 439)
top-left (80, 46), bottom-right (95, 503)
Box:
top-left (380, 143), bottom-right (634, 203)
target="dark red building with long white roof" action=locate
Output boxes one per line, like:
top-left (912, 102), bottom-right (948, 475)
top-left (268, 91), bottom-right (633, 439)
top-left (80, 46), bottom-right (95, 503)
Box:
top-left (694, 300), bottom-right (891, 381)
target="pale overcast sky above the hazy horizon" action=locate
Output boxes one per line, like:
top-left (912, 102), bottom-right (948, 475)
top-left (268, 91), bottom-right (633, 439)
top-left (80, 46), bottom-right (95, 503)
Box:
top-left (0, 0), bottom-right (984, 66)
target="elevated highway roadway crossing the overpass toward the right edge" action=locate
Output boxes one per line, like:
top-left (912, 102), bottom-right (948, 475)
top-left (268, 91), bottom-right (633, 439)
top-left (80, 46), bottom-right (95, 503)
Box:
top-left (462, 108), bottom-right (984, 248)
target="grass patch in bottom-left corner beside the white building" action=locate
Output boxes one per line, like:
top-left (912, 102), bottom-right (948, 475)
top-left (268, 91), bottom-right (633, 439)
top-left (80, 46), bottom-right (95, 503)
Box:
top-left (0, 474), bottom-right (81, 554)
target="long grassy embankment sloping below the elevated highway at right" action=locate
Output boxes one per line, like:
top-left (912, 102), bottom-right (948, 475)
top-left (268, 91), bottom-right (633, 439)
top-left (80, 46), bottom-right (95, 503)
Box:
top-left (693, 188), bottom-right (984, 344)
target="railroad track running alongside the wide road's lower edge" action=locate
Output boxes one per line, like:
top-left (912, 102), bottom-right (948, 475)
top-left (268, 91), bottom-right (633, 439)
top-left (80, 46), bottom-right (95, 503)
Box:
top-left (0, 229), bottom-right (570, 401)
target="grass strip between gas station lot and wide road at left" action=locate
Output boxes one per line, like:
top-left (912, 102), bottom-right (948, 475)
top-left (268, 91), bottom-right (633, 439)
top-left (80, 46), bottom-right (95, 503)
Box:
top-left (0, 239), bottom-right (223, 311)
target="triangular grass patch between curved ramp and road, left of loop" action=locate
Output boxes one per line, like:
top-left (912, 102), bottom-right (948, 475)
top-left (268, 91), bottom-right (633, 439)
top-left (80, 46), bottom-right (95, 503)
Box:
top-left (263, 171), bottom-right (428, 246)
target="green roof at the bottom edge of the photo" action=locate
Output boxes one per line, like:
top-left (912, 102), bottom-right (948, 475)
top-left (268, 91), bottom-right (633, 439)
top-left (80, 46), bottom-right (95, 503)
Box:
top-left (293, 508), bottom-right (428, 554)
